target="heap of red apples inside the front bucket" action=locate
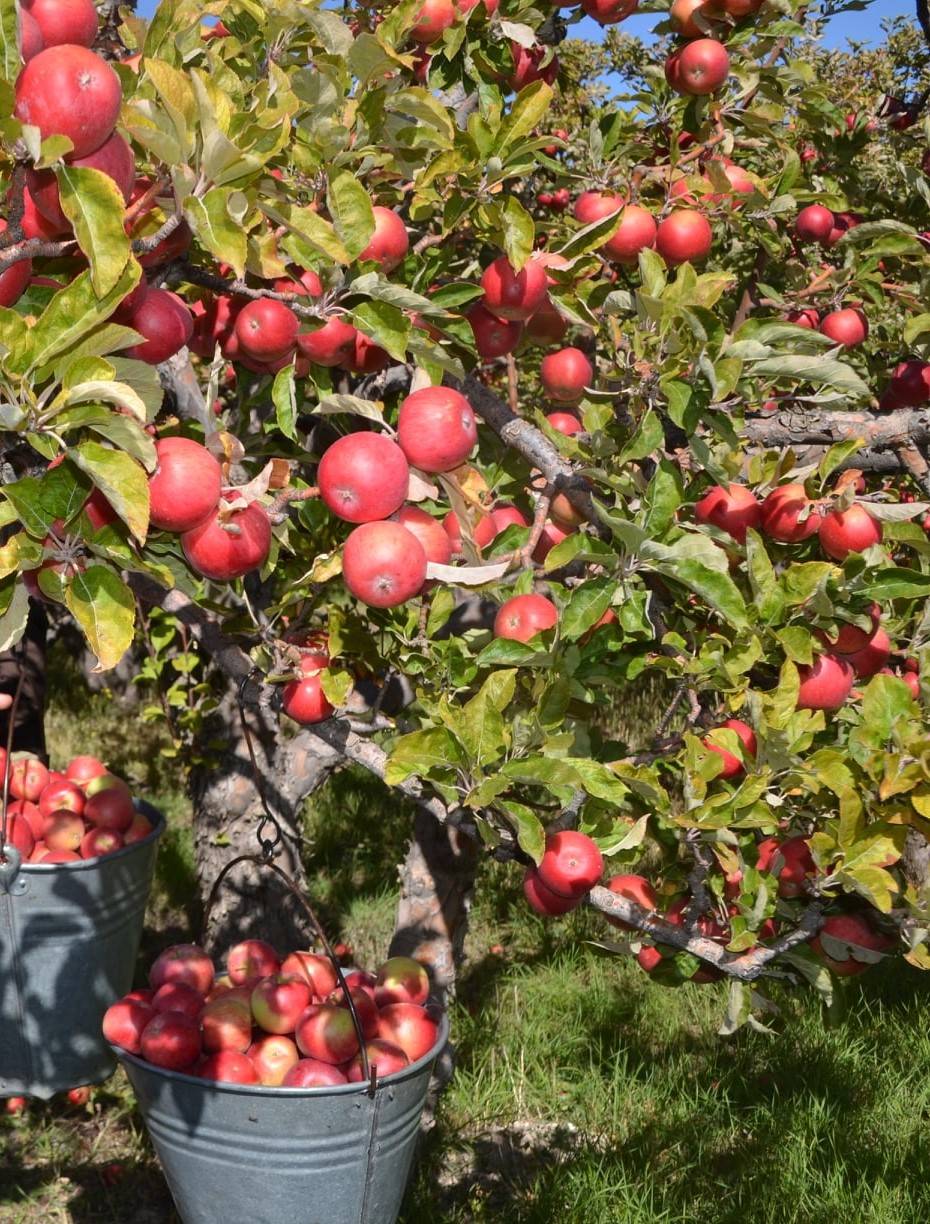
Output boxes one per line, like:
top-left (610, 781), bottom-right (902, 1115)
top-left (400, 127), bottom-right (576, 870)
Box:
top-left (103, 939), bottom-right (439, 1088)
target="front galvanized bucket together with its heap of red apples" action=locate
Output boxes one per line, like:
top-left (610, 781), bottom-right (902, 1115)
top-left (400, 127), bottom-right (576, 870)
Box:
top-left (103, 940), bottom-right (448, 1224)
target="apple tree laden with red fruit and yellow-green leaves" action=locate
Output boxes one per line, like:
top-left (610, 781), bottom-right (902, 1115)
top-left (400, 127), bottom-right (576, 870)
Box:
top-left (0, 0), bottom-right (930, 1029)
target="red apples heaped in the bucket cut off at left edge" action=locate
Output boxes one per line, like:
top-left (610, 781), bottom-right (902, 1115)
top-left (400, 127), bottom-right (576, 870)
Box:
top-left (0, 749), bottom-right (152, 867)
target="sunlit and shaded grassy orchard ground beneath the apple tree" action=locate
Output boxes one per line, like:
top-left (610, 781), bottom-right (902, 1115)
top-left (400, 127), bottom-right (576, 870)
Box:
top-left (0, 656), bottom-right (930, 1224)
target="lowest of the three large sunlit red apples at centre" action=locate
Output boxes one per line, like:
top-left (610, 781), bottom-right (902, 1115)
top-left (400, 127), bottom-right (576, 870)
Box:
top-left (343, 523), bottom-right (426, 608)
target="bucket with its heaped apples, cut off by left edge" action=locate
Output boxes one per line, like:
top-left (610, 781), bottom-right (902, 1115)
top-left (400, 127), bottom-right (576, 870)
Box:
top-left (0, 749), bottom-right (164, 1099)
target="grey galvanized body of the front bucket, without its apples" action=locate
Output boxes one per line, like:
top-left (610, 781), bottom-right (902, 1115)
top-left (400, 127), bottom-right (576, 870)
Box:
top-left (114, 1017), bottom-right (449, 1224)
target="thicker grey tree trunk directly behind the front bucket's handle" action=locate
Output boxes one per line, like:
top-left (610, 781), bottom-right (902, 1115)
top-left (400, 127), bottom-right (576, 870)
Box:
top-left (191, 695), bottom-right (340, 956)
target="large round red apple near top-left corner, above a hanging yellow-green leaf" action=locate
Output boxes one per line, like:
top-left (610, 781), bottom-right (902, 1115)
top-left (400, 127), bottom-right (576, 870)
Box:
top-left (13, 45), bottom-right (122, 157)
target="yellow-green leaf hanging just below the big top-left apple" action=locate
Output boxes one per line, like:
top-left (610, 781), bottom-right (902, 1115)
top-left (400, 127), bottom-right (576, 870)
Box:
top-left (55, 163), bottom-right (130, 297)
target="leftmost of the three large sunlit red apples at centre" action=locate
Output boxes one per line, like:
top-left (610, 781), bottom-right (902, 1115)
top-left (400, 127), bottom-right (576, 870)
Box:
top-left (317, 432), bottom-right (410, 523)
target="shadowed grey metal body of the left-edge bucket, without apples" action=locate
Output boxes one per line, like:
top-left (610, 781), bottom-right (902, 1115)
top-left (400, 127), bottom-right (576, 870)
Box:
top-left (0, 800), bottom-right (165, 1099)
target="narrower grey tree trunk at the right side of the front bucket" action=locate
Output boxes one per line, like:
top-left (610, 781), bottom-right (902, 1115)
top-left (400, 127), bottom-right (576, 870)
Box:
top-left (390, 812), bottom-right (478, 1006)
